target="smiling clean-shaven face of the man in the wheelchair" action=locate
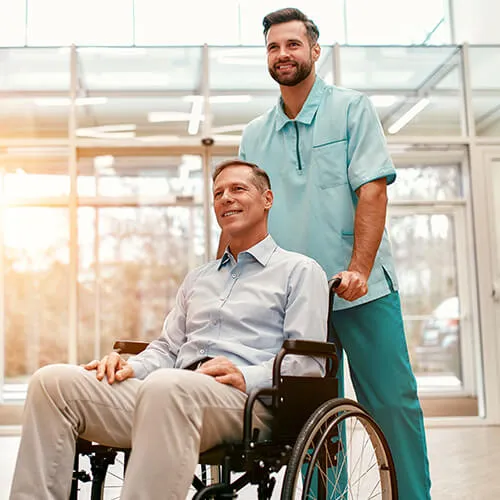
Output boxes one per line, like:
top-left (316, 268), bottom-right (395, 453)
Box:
top-left (213, 165), bottom-right (273, 245)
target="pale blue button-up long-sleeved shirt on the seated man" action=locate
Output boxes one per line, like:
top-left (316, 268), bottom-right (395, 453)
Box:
top-left (130, 236), bottom-right (328, 392)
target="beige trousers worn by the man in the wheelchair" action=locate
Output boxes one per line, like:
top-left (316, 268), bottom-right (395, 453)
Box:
top-left (10, 365), bottom-right (270, 500)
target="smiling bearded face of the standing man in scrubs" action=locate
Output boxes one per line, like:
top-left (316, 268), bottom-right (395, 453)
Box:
top-left (266, 21), bottom-right (320, 87)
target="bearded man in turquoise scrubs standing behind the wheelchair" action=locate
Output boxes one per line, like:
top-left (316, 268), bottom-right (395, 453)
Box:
top-left (234, 8), bottom-right (430, 500)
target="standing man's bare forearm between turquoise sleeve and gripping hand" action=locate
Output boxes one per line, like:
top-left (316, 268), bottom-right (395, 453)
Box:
top-left (348, 179), bottom-right (387, 279)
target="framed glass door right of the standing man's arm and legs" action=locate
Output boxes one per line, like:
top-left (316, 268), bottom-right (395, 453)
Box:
top-left (388, 150), bottom-right (481, 417)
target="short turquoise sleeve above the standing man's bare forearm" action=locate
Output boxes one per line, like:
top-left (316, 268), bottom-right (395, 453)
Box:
top-left (347, 94), bottom-right (396, 191)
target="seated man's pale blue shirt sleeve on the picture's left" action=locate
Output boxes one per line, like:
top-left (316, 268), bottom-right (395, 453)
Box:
top-left (129, 275), bottom-right (190, 380)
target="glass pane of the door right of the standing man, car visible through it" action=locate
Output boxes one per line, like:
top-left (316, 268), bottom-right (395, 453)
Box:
top-left (389, 213), bottom-right (463, 391)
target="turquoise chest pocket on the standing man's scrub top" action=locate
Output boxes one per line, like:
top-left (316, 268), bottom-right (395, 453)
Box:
top-left (311, 139), bottom-right (348, 189)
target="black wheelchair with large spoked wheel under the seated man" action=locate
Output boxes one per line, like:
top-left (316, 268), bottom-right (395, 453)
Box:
top-left (70, 282), bottom-right (398, 500)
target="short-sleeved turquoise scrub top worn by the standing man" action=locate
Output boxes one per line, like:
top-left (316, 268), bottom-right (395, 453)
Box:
top-left (240, 77), bottom-right (397, 309)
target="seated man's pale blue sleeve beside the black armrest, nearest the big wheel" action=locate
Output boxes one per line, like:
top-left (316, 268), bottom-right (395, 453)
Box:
top-left (240, 259), bottom-right (328, 393)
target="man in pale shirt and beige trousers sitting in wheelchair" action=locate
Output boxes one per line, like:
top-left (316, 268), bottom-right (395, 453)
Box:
top-left (10, 160), bottom-right (328, 500)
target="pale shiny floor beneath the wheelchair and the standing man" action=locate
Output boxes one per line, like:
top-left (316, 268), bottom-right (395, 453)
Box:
top-left (0, 427), bottom-right (500, 500)
